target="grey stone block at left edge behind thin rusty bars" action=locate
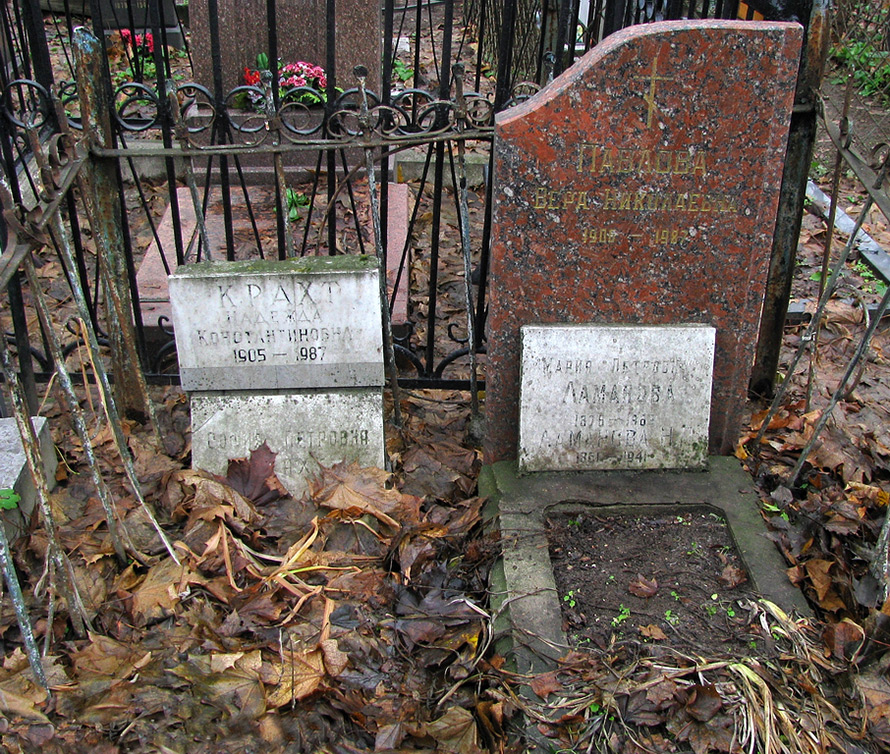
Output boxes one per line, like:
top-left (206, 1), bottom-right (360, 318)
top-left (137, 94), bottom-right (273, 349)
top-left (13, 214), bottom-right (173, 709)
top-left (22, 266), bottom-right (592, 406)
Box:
top-left (0, 416), bottom-right (58, 542)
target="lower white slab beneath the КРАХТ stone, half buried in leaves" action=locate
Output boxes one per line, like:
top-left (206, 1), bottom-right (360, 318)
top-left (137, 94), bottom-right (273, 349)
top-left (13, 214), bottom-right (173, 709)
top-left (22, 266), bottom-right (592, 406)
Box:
top-left (191, 388), bottom-right (385, 497)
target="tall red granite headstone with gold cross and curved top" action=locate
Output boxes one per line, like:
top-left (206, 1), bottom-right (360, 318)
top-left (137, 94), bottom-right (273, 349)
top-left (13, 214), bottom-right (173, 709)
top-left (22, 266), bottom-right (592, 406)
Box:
top-left (485, 21), bottom-right (801, 463)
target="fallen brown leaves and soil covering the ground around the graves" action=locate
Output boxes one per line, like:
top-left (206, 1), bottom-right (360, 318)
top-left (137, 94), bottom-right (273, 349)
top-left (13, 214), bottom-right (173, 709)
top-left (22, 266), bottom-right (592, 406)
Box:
top-left (0, 5), bottom-right (890, 754)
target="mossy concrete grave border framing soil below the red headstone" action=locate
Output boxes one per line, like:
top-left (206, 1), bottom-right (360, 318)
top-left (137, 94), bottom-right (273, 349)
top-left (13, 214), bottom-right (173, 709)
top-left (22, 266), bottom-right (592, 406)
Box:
top-left (479, 456), bottom-right (811, 752)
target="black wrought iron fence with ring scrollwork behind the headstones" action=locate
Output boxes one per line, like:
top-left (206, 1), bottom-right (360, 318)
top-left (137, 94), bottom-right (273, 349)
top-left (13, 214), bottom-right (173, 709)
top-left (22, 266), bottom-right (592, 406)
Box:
top-left (0, 0), bottom-right (820, 412)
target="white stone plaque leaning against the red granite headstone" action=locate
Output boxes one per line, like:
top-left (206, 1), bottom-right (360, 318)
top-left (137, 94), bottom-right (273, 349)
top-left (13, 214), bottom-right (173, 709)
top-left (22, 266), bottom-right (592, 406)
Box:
top-left (519, 325), bottom-right (716, 471)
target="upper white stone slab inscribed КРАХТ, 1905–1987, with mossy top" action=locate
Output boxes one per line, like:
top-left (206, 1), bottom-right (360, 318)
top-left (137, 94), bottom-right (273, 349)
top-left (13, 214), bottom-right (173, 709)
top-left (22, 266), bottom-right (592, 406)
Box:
top-left (169, 256), bottom-right (383, 391)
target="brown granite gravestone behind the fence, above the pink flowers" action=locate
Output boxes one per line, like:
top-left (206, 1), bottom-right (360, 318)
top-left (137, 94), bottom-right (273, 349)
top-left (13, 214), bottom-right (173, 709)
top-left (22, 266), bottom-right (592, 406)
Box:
top-left (189, 0), bottom-right (382, 92)
